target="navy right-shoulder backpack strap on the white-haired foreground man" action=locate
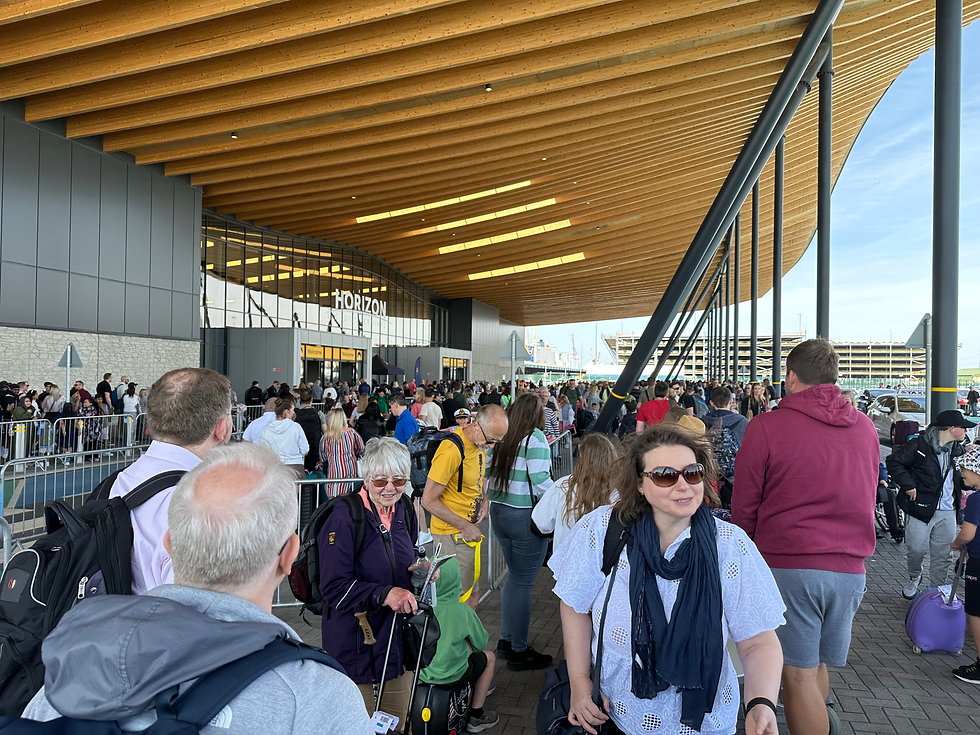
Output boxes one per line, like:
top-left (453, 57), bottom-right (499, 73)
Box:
top-left (156, 638), bottom-right (346, 733)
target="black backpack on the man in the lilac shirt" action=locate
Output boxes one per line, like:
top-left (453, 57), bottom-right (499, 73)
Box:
top-left (0, 470), bottom-right (185, 717)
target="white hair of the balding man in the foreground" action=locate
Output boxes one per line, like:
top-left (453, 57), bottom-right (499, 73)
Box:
top-left (167, 442), bottom-right (297, 592)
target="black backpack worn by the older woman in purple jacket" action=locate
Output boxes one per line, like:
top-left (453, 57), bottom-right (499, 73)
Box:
top-left (289, 491), bottom-right (418, 616)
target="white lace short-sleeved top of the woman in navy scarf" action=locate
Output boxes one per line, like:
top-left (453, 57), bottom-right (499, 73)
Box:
top-left (548, 506), bottom-right (786, 735)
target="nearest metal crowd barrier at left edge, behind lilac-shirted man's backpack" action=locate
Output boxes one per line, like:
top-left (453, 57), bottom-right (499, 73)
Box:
top-left (0, 447), bottom-right (143, 556)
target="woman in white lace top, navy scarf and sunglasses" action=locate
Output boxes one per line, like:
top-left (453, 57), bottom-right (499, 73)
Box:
top-left (549, 425), bottom-right (786, 735)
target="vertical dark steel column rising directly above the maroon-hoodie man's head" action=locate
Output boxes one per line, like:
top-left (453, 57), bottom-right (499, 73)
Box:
top-left (817, 29), bottom-right (834, 339)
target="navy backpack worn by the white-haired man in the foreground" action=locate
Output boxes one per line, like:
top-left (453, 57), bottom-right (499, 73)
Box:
top-left (0, 638), bottom-right (347, 735)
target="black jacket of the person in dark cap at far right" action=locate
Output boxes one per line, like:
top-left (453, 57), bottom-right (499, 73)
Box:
top-left (885, 429), bottom-right (963, 523)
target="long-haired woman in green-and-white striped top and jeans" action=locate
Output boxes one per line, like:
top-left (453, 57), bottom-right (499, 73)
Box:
top-left (487, 393), bottom-right (552, 671)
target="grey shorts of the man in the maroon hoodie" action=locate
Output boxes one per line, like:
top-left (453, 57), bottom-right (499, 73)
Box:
top-left (772, 569), bottom-right (865, 669)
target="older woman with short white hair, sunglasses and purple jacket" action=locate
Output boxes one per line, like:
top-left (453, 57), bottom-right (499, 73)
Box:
top-left (317, 438), bottom-right (418, 722)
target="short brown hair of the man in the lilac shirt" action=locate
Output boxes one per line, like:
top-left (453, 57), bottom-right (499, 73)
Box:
top-left (146, 368), bottom-right (231, 447)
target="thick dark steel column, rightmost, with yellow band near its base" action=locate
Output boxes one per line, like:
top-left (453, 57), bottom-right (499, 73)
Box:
top-left (927, 0), bottom-right (963, 421)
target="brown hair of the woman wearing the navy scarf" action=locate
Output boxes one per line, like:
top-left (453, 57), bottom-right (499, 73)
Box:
top-left (615, 424), bottom-right (721, 526)
